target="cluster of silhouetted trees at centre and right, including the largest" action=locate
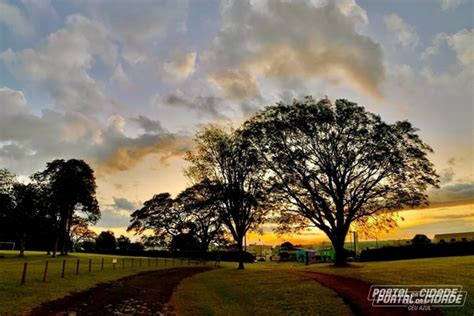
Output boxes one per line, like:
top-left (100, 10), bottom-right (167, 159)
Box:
top-left (129, 97), bottom-right (438, 269)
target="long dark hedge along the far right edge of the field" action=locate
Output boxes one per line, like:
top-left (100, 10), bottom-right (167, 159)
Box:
top-left (360, 242), bottom-right (474, 261)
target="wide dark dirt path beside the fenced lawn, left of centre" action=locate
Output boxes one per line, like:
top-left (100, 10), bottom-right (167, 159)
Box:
top-left (31, 267), bottom-right (210, 315)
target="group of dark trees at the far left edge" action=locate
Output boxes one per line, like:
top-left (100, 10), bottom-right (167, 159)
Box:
top-left (0, 159), bottom-right (100, 256)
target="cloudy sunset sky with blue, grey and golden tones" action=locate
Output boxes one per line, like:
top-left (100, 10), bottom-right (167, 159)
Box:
top-left (0, 0), bottom-right (474, 243)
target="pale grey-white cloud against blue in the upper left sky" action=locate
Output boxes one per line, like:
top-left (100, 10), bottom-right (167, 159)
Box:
top-left (0, 15), bottom-right (117, 113)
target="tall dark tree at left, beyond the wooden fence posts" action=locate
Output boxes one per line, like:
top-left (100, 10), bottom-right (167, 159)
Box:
top-left (33, 159), bottom-right (100, 255)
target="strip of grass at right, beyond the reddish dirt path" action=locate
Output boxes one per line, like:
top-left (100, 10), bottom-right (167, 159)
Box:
top-left (274, 256), bottom-right (474, 315)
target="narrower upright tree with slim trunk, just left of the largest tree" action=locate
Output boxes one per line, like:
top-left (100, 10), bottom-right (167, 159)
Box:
top-left (187, 127), bottom-right (268, 269)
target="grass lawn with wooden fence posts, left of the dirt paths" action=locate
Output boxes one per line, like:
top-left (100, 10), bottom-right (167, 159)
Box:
top-left (0, 251), bottom-right (193, 315)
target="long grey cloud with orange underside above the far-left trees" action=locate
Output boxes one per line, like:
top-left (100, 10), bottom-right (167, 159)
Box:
top-left (0, 88), bottom-right (192, 175)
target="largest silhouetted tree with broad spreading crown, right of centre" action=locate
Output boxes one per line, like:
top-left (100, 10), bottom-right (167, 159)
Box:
top-left (244, 97), bottom-right (438, 265)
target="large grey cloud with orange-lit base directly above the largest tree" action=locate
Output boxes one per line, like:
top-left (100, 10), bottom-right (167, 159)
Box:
top-left (203, 1), bottom-right (384, 99)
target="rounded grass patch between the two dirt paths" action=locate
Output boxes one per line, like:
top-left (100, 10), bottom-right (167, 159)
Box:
top-left (172, 263), bottom-right (351, 315)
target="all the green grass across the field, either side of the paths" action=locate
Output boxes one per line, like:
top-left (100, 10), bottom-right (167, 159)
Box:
top-left (0, 252), bottom-right (474, 315)
